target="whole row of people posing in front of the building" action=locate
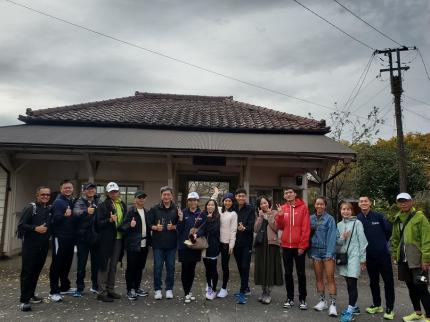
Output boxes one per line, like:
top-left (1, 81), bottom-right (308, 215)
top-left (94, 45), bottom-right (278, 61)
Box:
top-left (18, 180), bottom-right (430, 322)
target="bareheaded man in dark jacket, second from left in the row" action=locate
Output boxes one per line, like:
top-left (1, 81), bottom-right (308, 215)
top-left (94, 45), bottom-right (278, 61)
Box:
top-left (49, 180), bottom-right (76, 302)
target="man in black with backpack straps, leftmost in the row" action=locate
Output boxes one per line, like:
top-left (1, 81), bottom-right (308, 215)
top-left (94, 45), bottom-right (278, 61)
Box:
top-left (18, 186), bottom-right (51, 311)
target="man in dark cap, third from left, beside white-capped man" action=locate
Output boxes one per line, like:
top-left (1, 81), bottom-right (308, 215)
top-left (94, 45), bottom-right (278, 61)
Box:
top-left (73, 182), bottom-right (100, 297)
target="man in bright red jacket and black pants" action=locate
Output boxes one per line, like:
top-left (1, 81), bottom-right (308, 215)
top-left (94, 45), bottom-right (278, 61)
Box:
top-left (276, 187), bottom-right (311, 310)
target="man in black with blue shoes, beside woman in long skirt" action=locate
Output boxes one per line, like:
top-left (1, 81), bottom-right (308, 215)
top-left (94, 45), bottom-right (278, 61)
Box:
top-left (233, 188), bottom-right (255, 304)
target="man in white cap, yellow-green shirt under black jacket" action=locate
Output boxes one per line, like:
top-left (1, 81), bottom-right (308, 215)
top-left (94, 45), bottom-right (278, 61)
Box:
top-left (96, 182), bottom-right (127, 302)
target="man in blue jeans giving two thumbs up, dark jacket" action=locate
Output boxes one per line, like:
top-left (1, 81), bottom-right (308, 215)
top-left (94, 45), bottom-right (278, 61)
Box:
top-left (149, 187), bottom-right (178, 300)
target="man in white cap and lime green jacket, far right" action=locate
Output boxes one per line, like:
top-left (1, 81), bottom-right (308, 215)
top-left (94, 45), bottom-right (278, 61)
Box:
top-left (391, 192), bottom-right (430, 321)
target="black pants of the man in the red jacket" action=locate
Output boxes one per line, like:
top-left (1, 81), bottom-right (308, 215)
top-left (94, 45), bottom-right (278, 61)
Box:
top-left (282, 248), bottom-right (307, 301)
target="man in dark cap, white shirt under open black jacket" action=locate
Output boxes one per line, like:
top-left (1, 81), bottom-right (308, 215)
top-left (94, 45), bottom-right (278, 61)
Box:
top-left (120, 190), bottom-right (151, 300)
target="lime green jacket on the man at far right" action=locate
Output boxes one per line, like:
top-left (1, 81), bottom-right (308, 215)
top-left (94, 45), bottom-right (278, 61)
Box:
top-left (391, 208), bottom-right (430, 268)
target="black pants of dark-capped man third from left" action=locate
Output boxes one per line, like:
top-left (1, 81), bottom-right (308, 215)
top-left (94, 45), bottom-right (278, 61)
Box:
top-left (76, 241), bottom-right (98, 292)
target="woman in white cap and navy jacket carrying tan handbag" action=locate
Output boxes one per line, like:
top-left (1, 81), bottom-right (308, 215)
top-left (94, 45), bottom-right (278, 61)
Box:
top-left (177, 192), bottom-right (206, 303)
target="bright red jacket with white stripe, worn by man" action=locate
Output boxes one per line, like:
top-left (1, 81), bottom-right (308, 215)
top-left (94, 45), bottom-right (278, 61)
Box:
top-left (276, 198), bottom-right (311, 249)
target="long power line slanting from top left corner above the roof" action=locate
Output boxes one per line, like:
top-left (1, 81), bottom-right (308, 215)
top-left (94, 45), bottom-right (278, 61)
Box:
top-left (4, 0), bottom-right (386, 126)
